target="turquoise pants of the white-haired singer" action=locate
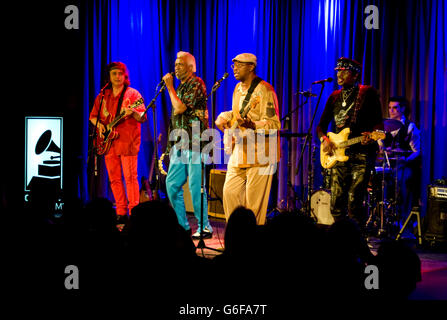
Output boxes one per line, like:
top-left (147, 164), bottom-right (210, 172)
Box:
top-left (166, 147), bottom-right (213, 232)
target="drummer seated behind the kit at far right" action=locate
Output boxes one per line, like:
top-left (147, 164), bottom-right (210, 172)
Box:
top-left (384, 96), bottom-right (421, 221)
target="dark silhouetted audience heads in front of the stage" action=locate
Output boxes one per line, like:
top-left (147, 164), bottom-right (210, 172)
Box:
top-left (16, 198), bottom-right (421, 303)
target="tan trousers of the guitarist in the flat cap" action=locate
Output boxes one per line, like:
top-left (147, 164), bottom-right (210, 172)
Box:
top-left (223, 164), bottom-right (276, 225)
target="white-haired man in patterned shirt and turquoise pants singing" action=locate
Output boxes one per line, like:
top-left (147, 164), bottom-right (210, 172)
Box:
top-left (163, 51), bottom-right (213, 238)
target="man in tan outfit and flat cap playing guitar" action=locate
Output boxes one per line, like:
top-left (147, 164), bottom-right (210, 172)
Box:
top-left (215, 53), bottom-right (281, 225)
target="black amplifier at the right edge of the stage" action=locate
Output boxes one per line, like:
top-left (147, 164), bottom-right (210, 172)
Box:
top-left (424, 186), bottom-right (447, 243)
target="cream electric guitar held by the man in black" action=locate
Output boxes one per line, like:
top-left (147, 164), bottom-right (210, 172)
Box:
top-left (320, 128), bottom-right (386, 169)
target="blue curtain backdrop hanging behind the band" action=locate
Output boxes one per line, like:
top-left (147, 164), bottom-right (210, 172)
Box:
top-left (81, 0), bottom-right (447, 215)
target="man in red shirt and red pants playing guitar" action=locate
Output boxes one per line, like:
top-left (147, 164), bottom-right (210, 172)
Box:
top-left (89, 62), bottom-right (146, 224)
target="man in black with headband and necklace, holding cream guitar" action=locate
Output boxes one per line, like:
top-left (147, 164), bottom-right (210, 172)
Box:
top-left (317, 57), bottom-right (383, 228)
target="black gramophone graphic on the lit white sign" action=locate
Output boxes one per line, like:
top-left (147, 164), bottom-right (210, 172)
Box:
top-left (29, 130), bottom-right (61, 187)
